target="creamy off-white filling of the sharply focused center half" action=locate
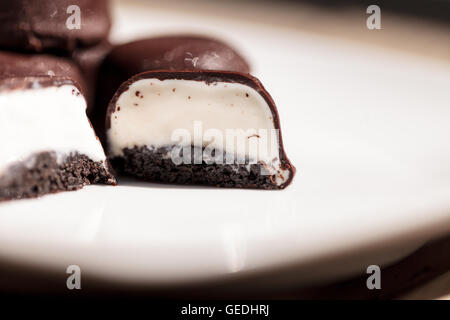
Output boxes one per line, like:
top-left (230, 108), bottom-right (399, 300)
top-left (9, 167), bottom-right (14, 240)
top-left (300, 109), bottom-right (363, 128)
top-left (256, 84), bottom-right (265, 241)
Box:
top-left (107, 79), bottom-right (289, 184)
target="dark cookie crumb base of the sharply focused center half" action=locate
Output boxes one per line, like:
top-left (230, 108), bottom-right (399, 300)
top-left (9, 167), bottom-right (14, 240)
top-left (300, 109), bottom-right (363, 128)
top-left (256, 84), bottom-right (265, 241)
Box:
top-left (110, 147), bottom-right (282, 190)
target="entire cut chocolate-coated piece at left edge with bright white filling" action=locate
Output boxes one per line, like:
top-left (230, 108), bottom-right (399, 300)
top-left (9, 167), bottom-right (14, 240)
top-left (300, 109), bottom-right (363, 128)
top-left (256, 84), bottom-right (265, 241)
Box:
top-left (0, 52), bottom-right (115, 201)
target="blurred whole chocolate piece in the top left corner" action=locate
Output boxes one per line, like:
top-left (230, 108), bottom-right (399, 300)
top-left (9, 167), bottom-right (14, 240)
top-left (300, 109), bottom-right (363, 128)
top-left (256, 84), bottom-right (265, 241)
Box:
top-left (0, 0), bottom-right (111, 52)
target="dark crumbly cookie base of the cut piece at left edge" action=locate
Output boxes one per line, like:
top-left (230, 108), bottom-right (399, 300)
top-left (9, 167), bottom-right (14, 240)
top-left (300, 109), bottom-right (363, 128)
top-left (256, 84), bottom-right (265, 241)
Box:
top-left (0, 152), bottom-right (116, 201)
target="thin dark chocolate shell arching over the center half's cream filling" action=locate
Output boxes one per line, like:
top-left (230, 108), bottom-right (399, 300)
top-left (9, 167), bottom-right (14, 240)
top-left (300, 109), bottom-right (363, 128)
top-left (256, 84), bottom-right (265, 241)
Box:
top-left (105, 70), bottom-right (295, 188)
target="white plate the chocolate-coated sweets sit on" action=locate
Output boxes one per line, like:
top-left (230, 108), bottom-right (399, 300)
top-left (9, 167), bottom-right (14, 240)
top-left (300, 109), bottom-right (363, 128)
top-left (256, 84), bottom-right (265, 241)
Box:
top-left (0, 1), bottom-right (450, 285)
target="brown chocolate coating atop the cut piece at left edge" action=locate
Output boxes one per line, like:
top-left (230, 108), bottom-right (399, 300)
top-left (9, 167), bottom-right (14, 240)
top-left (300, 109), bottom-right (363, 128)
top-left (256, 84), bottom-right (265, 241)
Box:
top-left (0, 51), bottom-right (85, 92)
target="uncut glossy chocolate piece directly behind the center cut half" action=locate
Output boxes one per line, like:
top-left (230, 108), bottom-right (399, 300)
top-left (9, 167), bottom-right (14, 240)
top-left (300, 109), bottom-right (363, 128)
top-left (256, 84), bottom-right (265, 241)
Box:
top-left (91, 35), bottom-right (250, 141)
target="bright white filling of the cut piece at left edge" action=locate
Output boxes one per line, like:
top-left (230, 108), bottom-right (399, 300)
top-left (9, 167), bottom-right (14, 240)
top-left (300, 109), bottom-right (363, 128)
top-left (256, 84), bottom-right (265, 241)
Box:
top-left (0, 85), bottom-right (105, 174)
